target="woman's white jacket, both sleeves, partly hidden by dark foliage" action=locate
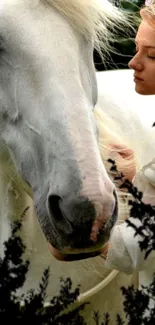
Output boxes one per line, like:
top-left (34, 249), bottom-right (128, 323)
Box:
top-left (105, 163), bottom-right (155, 294)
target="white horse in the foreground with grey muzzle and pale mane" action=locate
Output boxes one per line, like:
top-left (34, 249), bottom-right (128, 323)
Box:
top-left (0, 0), bottom-right (154, 324)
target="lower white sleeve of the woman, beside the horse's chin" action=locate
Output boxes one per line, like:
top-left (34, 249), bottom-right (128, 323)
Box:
top-left (105, 218), bottom-right (155, 274)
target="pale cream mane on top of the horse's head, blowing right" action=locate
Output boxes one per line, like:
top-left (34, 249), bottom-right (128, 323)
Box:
top-left (46, 0), bottom-right (130, 52)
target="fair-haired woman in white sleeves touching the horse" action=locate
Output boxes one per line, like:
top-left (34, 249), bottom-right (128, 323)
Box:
top-left (104, 1), bottom-right (155, 302)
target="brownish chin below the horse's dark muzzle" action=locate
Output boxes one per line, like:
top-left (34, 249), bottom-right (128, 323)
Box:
top-left (49, 244), bottom-right (103, 262)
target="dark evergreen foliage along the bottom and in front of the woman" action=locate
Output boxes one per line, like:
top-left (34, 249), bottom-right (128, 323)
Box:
top-left (0, 160), bottom-right (155, 325)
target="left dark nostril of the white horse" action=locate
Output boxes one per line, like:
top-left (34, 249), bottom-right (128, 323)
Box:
top-left (48, 195), bottom-right (64, 221)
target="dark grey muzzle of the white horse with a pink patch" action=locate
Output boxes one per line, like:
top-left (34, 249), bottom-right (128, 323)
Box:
top-left (48, 187), bottom-right (118, 253)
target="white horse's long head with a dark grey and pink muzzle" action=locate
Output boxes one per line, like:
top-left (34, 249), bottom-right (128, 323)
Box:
top-left (0, 0), bottom-right (126, 258)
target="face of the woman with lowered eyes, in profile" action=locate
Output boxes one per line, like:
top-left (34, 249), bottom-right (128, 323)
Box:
top-left (129, 20), bottom-right (155, 95)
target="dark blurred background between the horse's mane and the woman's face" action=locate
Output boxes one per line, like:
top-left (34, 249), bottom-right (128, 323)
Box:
top-left (94, 0), bottom-right (145, 71)
